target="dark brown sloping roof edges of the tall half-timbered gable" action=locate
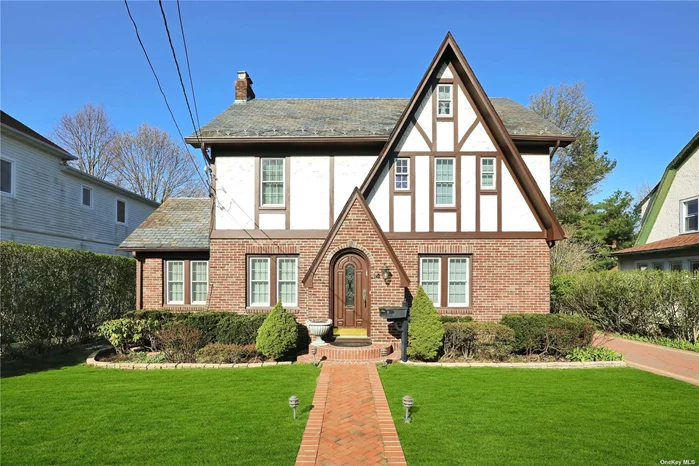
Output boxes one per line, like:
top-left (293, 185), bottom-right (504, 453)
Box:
top-left (361, 32), bottom-right (565, 241)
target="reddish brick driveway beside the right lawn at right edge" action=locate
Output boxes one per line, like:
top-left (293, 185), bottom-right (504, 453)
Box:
top-left (595, 335), bottom-right (699, 385)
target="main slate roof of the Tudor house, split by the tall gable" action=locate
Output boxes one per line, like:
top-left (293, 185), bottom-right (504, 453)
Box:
top-left (190, 97), bottom-right (572, 138)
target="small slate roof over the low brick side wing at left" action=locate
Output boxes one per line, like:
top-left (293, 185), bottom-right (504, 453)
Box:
top-left (119, 197), bottom-right (211, 251)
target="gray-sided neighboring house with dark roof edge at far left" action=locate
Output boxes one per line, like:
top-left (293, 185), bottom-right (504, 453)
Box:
top-left (0, 112), bottom-right (158, 254)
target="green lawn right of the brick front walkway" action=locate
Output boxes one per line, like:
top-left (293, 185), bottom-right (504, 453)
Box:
top-left (379, 366), bottom-right (699, 465)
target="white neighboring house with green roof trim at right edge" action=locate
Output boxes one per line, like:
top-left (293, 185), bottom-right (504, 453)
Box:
top-left (615, 133), bottom-right (699, 272)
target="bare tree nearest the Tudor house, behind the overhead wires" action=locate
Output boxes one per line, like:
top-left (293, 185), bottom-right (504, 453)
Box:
top-left (113, 124), bottom-right (206, 202)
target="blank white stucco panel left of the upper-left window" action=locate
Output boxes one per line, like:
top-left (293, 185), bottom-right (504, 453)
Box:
top-left (216, 157), bottom-right (255, 230)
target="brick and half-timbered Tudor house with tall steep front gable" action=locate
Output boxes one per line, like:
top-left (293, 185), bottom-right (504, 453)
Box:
top-left (121, 35), bottom-right (574, 342)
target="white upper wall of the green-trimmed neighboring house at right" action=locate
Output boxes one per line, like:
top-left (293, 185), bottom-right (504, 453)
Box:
top-left (647, 149), bottom-right (699, 243)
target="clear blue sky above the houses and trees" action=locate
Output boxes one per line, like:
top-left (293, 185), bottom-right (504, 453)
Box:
top-left (0, 1), bottom-right (699, 199)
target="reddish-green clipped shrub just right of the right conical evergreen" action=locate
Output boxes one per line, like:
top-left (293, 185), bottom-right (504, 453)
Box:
top-left (444, 322), bottom-right (515, 360)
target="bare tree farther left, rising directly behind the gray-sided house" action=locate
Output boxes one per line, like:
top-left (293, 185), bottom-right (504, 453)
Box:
top-left (51, 103), bottom-right (117, 179)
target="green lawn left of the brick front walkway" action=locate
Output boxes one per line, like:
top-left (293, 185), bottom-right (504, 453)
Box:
top-left (0, 353), bottom-right (318, 465)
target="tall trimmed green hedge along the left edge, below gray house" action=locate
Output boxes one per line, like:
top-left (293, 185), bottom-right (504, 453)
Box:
top-left (0, 241), bottom-right (136, 345)
